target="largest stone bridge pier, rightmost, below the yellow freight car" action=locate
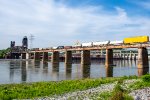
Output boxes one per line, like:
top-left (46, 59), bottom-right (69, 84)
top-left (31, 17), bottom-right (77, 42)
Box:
top-left (138, 48), bottom-right (149, 68)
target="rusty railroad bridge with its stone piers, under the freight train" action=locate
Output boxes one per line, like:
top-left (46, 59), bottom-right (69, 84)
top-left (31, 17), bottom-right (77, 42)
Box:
top-left (21, 43), bottom-right (150, 68)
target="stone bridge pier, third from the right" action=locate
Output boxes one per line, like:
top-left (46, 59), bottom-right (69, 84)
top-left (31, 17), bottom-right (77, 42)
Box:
top-left (81, 50), bottom-right (91, 65)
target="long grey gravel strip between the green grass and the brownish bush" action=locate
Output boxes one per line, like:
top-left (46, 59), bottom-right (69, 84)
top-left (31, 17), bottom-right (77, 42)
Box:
top-left (38, 83), bottom-right (116, 100)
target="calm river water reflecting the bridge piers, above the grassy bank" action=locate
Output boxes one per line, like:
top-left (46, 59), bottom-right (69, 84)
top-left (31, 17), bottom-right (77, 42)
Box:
top-left (0, 60), bottom-right (149, 84)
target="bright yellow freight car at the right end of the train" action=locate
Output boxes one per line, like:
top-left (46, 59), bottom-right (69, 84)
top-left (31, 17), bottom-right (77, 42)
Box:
top-left (124, 36), bottom-right (149, 44)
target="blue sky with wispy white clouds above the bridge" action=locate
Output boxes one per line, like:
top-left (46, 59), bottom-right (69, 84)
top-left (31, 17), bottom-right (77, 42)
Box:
top-left (0, 0), bottom-right (150, 49)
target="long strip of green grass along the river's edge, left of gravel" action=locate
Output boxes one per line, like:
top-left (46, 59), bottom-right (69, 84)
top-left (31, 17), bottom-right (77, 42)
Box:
top-left (0, 76), bottom-right (142, 100)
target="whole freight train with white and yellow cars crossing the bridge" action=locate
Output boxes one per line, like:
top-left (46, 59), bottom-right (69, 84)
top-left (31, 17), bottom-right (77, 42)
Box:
top-left (29, 36), bottom-right (149, 50)
